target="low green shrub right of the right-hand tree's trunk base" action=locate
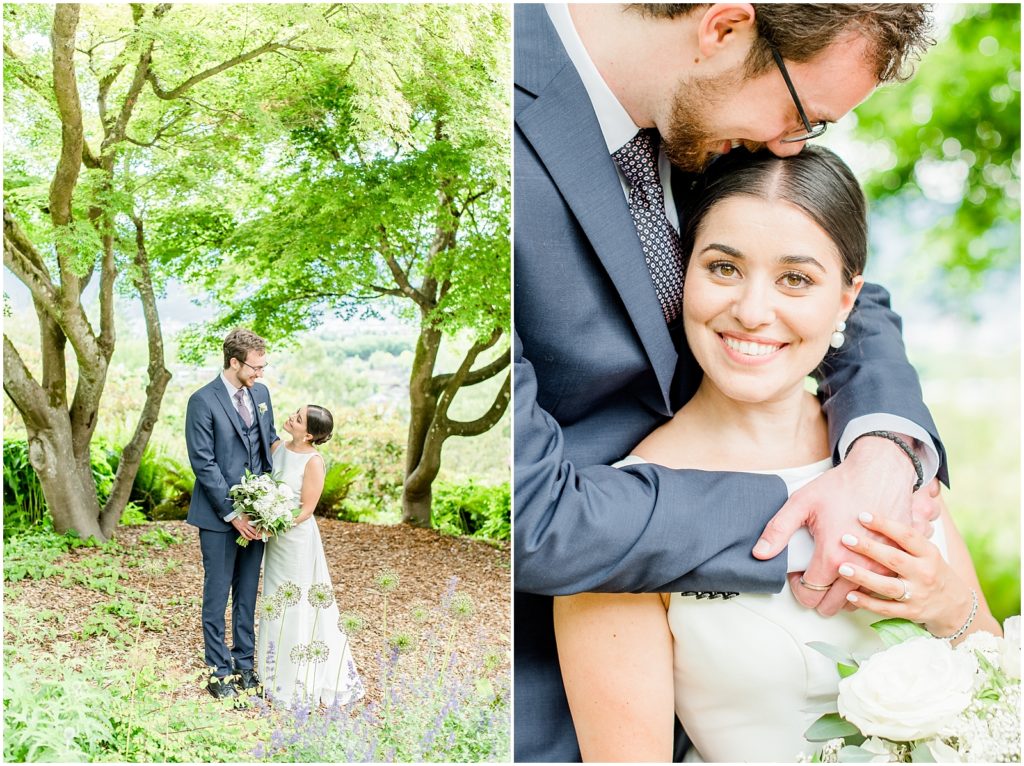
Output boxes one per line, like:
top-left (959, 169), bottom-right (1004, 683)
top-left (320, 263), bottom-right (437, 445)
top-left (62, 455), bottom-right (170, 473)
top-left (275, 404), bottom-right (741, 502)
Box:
top-left (431, 481), bottom-right (512, 540)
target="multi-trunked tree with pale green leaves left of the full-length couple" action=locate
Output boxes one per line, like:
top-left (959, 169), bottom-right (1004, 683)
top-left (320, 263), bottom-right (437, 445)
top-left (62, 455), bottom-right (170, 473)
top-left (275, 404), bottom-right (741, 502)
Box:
top-left (4, 3), bottom-right (362, 540)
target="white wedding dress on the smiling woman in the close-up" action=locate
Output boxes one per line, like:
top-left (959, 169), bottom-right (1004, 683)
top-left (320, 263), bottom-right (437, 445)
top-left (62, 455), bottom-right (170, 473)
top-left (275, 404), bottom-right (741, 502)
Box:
top-left (617, 456), bottom-right (946, 763)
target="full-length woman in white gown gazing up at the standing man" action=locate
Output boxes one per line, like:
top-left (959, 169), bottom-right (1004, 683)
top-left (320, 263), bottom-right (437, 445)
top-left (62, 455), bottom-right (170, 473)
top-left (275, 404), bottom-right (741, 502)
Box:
top-left (258, 405), bottom-right (364, 705)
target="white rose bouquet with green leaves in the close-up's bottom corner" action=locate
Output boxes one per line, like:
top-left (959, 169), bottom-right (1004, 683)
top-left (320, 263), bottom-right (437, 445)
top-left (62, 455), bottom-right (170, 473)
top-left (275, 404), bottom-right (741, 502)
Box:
top-left (804, 616), bottom-right (1021, 763)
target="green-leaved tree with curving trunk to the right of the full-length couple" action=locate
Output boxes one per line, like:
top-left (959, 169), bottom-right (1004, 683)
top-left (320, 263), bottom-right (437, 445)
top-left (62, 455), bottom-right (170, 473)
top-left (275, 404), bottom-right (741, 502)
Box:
top-left (162, 5), bottom-right (510, 526)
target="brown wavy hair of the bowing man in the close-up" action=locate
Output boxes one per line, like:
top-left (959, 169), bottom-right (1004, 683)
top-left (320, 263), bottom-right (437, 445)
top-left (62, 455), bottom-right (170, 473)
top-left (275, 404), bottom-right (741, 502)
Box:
top-left (627, 3), bottom-right (935, 83)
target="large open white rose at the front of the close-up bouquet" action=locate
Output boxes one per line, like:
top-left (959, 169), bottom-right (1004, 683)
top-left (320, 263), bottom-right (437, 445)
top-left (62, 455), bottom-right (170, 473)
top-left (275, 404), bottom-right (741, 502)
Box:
top-left (839, 636), bottom-right (978, 741)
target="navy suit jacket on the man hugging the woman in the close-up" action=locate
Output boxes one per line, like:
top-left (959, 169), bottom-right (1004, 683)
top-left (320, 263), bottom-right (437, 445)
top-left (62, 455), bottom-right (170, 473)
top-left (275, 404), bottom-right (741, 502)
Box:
top-left (514, 5), bottom-right (944, 761)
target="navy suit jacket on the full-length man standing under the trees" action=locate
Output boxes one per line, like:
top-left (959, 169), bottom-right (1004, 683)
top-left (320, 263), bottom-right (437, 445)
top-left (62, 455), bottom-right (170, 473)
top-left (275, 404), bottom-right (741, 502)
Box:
top-left (185, 375), bottom-right (278, 531)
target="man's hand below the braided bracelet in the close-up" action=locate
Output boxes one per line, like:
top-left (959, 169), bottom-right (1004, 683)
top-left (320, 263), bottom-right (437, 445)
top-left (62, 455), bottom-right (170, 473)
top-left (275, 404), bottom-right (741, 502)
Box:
top-left (754, 437), bottom-right (931, 616)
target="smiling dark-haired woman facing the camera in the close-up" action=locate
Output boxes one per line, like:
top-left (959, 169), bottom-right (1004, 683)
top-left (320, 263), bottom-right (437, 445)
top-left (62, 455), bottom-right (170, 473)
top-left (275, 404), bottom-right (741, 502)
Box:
top-left (554, 146), bottom-right (999, 762)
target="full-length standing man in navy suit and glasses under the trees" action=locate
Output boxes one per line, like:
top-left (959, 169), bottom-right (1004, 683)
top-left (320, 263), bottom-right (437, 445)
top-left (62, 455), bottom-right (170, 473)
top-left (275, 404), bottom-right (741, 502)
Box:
top-left (185, 330), bottom-right (278, 699)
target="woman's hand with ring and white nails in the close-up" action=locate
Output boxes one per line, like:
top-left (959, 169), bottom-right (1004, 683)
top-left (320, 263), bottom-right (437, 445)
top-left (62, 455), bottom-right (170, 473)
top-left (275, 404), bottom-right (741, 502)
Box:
top-left (839, 513), bottom-right (973, 636)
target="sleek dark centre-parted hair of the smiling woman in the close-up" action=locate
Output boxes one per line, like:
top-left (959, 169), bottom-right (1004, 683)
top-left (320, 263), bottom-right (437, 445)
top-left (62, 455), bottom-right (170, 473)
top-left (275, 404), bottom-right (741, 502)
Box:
top-left (681, 145), bottom-right (867, 285)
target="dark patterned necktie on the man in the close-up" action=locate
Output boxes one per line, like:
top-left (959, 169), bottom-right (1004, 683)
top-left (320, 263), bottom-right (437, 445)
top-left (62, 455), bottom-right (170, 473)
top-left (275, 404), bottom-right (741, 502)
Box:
top-left (611, 128), bottom-right (683, 324)
